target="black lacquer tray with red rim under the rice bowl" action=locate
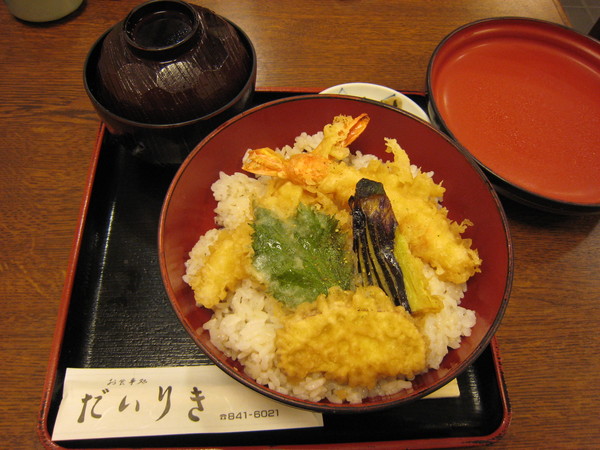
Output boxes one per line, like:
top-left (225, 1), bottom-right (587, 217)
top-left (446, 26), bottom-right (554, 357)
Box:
top-left (38, 92), bottom-right (511, 448)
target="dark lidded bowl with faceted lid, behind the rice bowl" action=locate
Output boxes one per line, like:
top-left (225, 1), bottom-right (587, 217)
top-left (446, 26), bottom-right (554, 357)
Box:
top-left (84, 0), bottom-right (257, 165)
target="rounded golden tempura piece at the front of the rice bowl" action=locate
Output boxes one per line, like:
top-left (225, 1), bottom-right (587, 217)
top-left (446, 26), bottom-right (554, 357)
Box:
top-left (276, 286), bottom-right (426, 388)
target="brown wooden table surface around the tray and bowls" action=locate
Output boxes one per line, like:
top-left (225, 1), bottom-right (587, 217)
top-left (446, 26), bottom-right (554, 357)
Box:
top-left (0, 0), bottom-right (600, 449)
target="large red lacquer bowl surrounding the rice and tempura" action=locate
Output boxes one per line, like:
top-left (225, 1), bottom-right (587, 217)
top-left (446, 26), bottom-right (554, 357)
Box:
top-left (159, 95), bottom-right (513, 412)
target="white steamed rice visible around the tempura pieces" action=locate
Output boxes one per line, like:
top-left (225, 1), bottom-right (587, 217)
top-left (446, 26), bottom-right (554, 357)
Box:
top-left (184, 128), bottom-right (476, 403)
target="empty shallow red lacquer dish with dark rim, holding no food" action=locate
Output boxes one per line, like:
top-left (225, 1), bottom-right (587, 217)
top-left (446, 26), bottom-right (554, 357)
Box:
top-left (427, 17), bottom-right (600, 214)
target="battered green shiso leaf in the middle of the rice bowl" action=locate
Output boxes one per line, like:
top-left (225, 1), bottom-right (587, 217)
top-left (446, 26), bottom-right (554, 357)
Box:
top-left (252, 204), bottom-right (353, 308)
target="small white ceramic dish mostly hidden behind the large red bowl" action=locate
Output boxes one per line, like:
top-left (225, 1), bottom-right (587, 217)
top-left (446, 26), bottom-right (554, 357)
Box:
top-left (320, 83), bottom-right (431, 123)
